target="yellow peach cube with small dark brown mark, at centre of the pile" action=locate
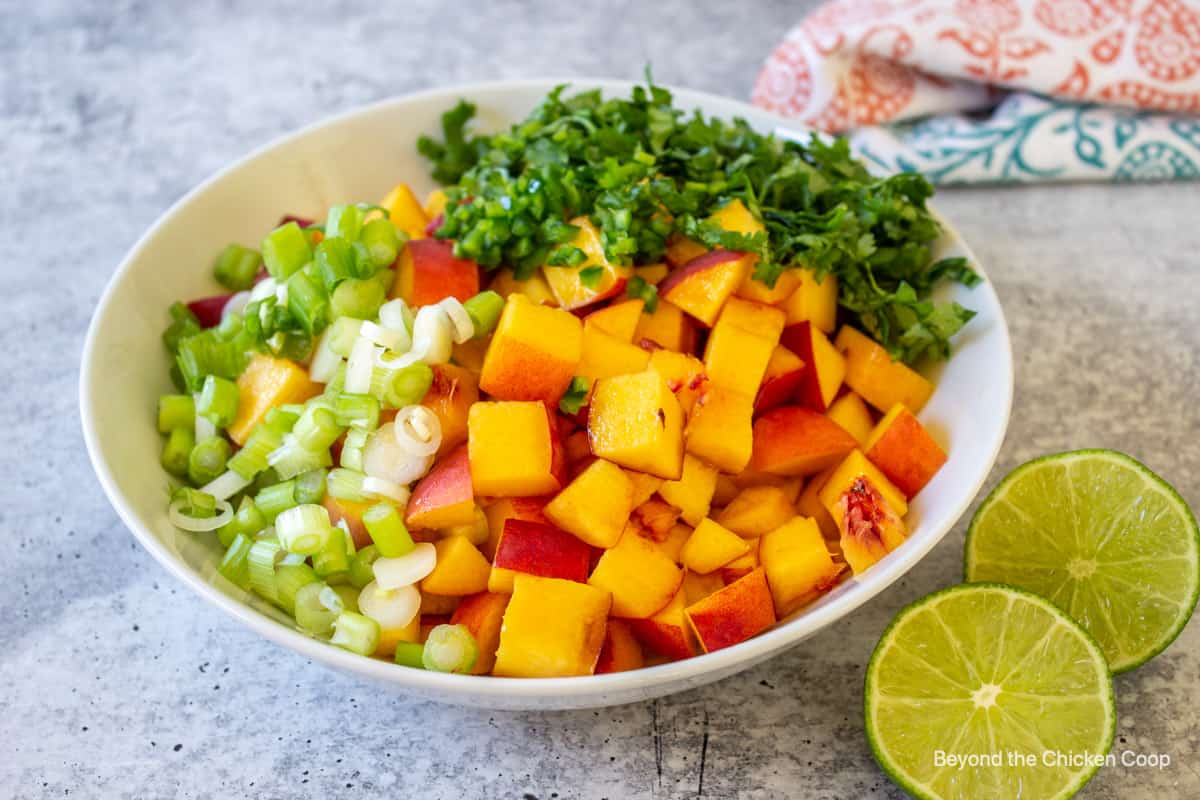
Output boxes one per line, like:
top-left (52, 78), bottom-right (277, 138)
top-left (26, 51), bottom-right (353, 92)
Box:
top-left (588, 371), bottom-right (683, 480)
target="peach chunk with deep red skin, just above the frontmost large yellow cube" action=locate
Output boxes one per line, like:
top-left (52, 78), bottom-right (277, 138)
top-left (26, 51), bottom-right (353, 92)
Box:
top-left (487, 519), bottom-right (592, 594)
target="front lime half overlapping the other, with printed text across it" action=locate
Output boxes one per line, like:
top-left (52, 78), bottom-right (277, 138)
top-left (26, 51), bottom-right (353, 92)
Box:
top-left (865, 583), bottom-right (1116, 800)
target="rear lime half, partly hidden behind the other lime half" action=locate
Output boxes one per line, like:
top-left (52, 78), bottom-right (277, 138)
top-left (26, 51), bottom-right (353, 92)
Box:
top-left (966, 450), bottom-right (1200, 672)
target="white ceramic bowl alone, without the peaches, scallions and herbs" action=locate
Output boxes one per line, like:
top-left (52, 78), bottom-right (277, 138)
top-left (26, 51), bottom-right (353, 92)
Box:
top-left (79, 80), bottom-right (1013, 709)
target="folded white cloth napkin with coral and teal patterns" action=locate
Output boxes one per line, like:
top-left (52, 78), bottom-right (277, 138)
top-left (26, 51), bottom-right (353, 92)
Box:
top-left (754, 0), bottom-right (1200, 184)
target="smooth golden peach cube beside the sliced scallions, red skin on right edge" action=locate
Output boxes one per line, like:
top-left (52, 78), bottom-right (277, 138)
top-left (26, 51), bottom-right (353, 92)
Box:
top-left (467, 402), bottom-right (565, 497)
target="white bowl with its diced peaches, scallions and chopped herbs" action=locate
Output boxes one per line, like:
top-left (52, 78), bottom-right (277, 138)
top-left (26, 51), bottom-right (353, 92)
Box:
top-left (80, 80), bottom-right (1012, 708)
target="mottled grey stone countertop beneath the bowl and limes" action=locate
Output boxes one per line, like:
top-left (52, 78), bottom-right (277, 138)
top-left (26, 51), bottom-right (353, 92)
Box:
top-left (0, 0), bottom-right (1200, 800)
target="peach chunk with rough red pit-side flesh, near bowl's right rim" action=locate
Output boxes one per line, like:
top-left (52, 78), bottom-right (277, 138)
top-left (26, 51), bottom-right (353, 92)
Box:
top-left (821, 450), bottom-right (908, 575)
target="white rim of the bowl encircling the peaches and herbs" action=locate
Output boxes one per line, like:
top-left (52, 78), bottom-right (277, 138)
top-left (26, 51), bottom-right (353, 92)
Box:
top-left (79, 77), bottom-right (1014, 708)
